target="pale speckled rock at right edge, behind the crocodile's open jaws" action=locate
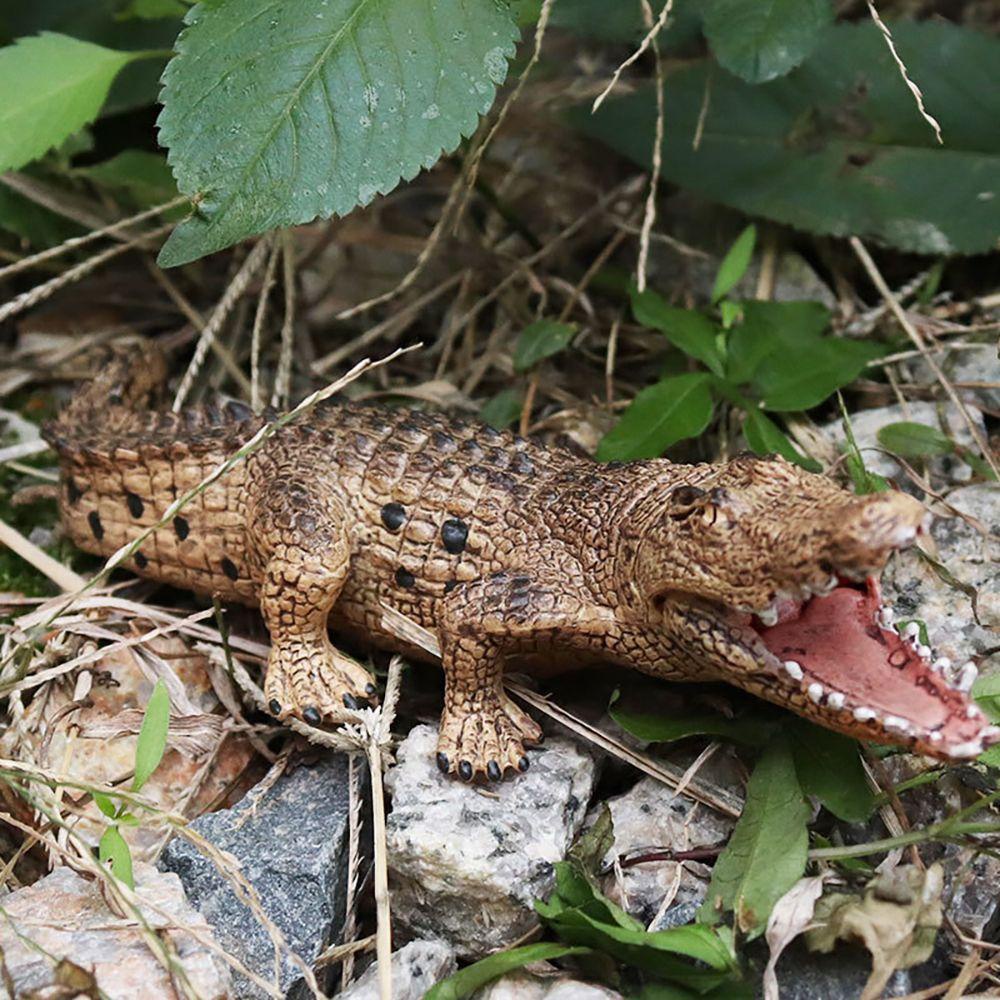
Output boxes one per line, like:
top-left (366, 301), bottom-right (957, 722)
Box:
top-left (882, 483), bottom-right (1000, 671)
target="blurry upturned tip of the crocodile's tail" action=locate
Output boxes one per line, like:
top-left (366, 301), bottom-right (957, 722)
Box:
top-left (42, 337), bottom-right (167, 451)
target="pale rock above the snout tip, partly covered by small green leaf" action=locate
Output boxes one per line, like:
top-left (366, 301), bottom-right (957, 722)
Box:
top-left (823, 401), bottom-right (985, 491)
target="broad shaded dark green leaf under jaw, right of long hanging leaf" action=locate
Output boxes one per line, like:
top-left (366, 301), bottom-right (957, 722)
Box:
top-left (785, 718), bottom-right (875, 823)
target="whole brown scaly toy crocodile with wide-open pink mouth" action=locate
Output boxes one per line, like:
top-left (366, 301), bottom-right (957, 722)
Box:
top-left (45, 342), bottom-right (1000, 781)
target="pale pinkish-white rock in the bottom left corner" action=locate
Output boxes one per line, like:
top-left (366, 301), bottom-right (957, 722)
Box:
top-left (0, 864), bottom-right (231, 1000)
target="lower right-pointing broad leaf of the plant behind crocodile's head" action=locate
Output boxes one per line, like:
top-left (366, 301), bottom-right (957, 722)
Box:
top-left (754, 337), bottom-right (882, 412)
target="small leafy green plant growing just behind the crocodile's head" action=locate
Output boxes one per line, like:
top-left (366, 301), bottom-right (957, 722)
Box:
top-left (597, 226), bottom-right (882, 469)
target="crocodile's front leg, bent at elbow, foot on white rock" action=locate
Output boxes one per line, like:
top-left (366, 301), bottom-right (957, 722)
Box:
top-left (437, 573), bottom-right (614, 781)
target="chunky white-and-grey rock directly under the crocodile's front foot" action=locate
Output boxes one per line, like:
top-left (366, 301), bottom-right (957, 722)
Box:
top-left (386, 726), bottom-right (595, 958)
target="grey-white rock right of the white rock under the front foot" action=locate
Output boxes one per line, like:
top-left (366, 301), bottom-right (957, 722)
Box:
top-left (592, 778), bottom-right (733, 930)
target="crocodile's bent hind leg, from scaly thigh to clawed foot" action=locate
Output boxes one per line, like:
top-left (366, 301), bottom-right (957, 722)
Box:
top-left (248, 477), bottom-right (375, 725)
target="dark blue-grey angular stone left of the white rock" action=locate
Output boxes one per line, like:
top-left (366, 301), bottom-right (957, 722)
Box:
top-left (160, 754), bottom-right (366, 998)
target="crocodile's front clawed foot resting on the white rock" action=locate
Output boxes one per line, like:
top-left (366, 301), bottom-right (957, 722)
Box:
top-left (437, 696), bottom-right (543, 781)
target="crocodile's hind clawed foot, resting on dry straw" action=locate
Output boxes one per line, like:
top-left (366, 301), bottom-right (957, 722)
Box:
top-left (264, 642), bottom-right (378, 726)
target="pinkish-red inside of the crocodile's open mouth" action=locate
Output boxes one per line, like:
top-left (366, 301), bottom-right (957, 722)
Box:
top-left (753, 578), bottom-right (960, 729)
